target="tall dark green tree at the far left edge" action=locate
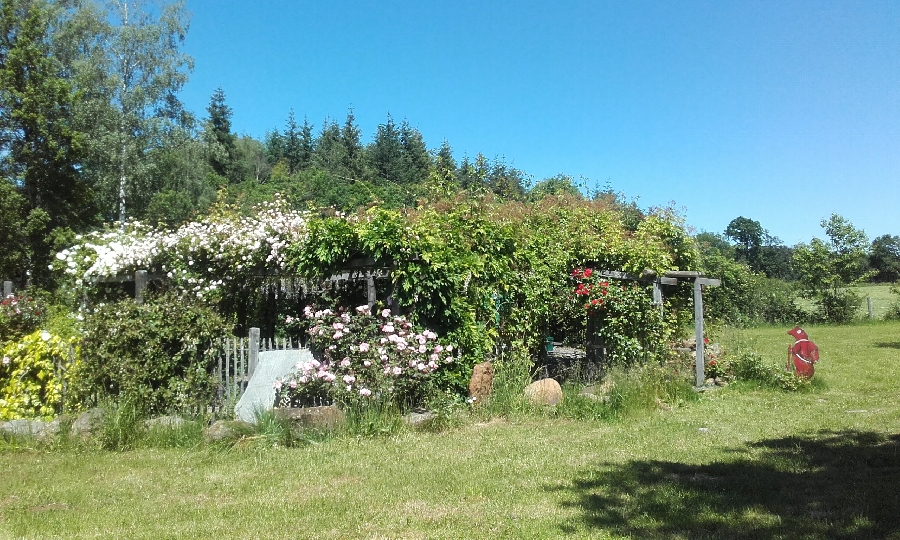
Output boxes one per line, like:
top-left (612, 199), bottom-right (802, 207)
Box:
top-left (0, 0), bottom-right (97, 285)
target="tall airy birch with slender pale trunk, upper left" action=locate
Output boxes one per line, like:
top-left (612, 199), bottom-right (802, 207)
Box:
top-left (77, 0), bottom-right (193, 221)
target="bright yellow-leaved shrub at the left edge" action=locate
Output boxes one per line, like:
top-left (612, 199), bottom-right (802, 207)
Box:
top-left (0, 330), bottom-right (78, 420)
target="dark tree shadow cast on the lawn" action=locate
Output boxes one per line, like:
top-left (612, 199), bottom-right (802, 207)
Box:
top-left (552, 431), bottom-right (900, 539)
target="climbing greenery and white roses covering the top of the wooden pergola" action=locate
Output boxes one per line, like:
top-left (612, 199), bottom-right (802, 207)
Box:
top-left (57, 196), bottom-right (698, 380)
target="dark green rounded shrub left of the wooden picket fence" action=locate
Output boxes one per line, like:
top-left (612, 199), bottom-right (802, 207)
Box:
top-left (72, 294), bottom-right (226, 415)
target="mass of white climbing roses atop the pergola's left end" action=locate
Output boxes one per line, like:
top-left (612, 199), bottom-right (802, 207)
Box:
top-left (54, 198), bottom-right (309, 298)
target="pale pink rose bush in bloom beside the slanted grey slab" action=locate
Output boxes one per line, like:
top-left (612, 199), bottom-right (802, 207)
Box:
top-left (275, 306), bottom-right (455, 404)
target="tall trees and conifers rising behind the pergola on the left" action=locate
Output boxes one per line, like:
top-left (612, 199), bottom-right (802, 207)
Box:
top-left (0, 0), bottom-right (579, 292)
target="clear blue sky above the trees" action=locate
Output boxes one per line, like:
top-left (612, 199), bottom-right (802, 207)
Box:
top-left (182, 0), bottom-right (900, 245)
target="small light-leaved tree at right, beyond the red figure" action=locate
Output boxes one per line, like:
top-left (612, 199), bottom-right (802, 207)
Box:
top-left (793, 214), bottom-right (871, 322)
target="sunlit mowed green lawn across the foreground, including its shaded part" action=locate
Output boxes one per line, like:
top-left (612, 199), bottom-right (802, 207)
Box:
top-left (0, 323), bottom-right (900, 539)
